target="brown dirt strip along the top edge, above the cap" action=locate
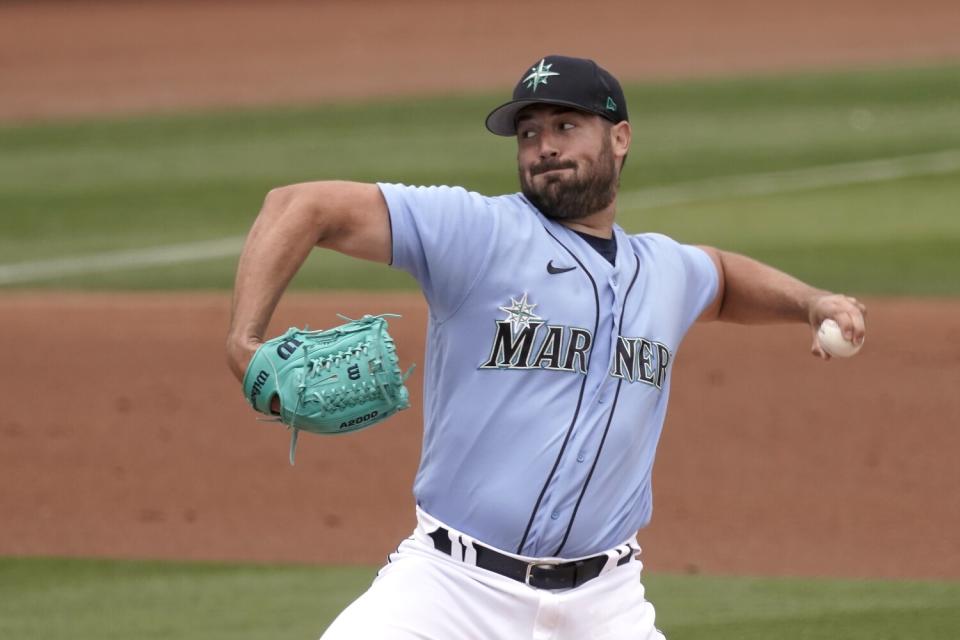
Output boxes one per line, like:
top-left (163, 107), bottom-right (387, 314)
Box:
top-left (0, 0), bottom-right (960, 119)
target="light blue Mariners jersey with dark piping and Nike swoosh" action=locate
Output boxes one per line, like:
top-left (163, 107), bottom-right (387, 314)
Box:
top-left (380, 184), bottom-right (717, 558)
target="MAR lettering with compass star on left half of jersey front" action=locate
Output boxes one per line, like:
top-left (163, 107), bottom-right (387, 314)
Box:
top-left (480, 293), bottom-right (593, 373)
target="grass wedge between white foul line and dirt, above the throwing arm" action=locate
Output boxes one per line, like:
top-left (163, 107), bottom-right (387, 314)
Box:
top-left (621, 174), bottom-right (960, 295)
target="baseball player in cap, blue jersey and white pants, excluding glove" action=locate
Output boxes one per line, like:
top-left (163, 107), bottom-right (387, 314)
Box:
top-left (227, 55), bottom-right (865, 640)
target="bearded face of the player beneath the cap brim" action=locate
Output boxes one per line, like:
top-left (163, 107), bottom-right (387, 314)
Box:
top-left (517, 105), bottom-right (619, 220)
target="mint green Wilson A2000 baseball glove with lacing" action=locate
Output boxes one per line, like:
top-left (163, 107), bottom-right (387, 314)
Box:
top-left (243, 315), bottom-right (413, 464)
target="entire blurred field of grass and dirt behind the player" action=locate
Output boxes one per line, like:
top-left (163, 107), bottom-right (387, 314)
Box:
top-left (0, 0), bottom-right (960, 639)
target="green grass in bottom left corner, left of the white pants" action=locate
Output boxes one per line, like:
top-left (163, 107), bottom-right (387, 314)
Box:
top-left (0, 559), bottom-right (376, 640)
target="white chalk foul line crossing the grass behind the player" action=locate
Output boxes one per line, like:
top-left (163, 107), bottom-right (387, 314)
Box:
top-left (0, 149), bottom-right (960, 286)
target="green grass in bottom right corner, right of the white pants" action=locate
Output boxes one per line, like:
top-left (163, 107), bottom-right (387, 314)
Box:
top-left (644, 575), bottom-right (960, 640)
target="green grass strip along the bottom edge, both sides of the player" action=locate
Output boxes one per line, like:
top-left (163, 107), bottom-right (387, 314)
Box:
top-left (0, 558), bottom-right (960, 640)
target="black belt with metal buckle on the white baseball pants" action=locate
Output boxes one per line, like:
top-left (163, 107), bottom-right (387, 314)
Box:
top-left (427, 527), bottom-right (635, 589)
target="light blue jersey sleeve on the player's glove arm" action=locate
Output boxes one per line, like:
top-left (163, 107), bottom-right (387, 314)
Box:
top-left (377, 183), bottom-right (498, 321)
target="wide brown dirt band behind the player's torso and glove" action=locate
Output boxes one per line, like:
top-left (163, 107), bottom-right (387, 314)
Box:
top-left (0, 294), bottom-right (960, 578)
